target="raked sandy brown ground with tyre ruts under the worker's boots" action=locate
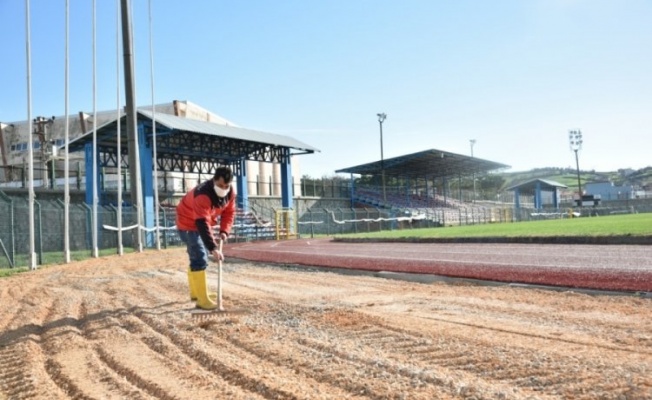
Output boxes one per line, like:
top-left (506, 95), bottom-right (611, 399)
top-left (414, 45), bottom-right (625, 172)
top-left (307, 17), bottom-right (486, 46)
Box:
top-left (0, 249), bottom-right (652, 399)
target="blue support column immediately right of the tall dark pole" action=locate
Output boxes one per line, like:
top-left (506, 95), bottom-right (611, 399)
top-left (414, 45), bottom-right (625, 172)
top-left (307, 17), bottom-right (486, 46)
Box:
top-left (138, 123), bottom-right (156, 247)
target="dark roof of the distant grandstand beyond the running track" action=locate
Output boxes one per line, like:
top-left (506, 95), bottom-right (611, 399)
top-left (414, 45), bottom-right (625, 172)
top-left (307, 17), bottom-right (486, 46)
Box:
top-left (335, 149), bottom-right (509, 178)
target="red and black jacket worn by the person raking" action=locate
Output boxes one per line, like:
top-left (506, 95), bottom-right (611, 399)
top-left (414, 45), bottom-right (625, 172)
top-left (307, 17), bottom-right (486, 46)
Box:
top-left (176, 179), bottom-right (236, 252)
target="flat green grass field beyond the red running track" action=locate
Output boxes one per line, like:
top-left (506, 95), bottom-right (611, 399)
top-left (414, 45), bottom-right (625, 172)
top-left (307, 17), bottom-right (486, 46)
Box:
top-left (337, 213), bottom-right (652, 239)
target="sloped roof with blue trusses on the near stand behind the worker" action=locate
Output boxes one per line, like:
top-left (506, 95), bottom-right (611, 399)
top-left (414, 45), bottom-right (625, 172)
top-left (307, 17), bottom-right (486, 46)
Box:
top-left (70, 110), bottom-right (319, 173)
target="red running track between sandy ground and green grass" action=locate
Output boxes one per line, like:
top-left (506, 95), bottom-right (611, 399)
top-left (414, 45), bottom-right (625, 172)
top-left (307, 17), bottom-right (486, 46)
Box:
top-left (225, 239), bottom-right (652, 292)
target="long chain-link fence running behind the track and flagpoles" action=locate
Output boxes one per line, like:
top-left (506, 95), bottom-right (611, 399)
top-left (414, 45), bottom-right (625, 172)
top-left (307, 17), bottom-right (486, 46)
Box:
top-left (0, 191), bottom-right (652, 268)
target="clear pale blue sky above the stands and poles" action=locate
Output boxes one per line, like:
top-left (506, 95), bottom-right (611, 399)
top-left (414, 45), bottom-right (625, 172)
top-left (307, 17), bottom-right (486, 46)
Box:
top-left (0, 0), bottom-right (652, 177)
